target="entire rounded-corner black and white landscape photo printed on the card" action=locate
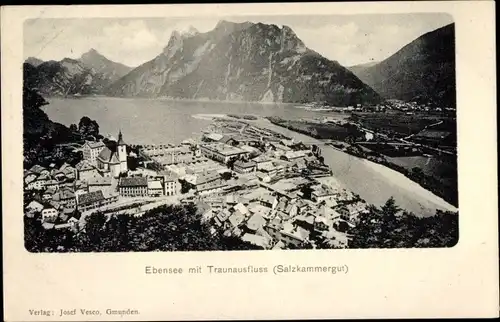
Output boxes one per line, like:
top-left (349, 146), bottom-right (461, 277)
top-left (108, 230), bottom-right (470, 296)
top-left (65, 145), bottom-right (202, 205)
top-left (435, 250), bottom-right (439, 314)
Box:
top-left (22, 12), bottom-right (459, 253)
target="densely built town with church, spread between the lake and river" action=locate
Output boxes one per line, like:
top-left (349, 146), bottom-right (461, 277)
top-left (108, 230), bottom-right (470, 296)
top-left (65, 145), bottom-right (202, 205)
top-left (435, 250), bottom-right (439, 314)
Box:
top-left (24, 118), bottom-right (367, 249)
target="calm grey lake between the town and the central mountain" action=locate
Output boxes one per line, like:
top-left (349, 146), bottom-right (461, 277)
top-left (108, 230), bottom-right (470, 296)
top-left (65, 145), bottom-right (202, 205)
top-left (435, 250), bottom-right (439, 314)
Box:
top-left (43, 97), bottom-right (347, 144)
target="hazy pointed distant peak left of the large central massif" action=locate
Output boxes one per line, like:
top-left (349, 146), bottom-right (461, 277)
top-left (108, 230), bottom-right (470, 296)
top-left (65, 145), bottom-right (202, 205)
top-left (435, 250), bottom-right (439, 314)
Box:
top-left (79, 48), bottom-right (132, 83)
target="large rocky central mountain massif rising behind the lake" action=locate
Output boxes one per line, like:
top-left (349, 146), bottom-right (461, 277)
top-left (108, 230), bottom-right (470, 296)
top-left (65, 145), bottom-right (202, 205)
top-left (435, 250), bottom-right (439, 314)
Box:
top-left (105, 20), bottom-right (380, 106)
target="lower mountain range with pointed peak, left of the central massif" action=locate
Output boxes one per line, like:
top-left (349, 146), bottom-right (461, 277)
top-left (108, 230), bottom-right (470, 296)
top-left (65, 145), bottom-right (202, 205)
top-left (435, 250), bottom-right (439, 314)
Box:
top-left (23, 49), bottom-right (131, 96)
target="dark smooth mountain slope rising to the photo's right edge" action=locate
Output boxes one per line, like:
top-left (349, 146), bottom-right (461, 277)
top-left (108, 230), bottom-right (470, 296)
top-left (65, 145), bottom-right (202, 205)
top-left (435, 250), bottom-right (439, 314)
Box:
top-left (351, 24), bottom-right (456, 107)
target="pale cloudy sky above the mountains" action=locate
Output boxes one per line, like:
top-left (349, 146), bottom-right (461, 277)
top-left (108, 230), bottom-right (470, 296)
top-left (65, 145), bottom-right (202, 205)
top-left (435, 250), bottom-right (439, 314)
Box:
top-left (24, 13), bottom-right (453, 67)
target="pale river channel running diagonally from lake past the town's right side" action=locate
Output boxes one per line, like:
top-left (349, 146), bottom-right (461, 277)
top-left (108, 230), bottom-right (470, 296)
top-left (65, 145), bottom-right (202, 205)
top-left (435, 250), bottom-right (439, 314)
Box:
top-left (248, 118), bottom-right (457, 217)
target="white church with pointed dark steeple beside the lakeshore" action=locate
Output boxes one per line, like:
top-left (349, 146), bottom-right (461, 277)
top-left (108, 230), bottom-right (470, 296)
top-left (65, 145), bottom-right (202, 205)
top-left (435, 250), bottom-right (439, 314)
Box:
top-left (97, 131), bottom-right (128, 178)
